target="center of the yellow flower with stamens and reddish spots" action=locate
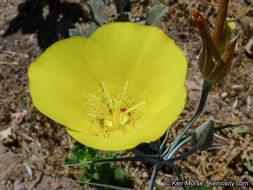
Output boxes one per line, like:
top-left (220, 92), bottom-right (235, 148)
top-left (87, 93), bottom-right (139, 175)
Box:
top-left (85, 82), bottom-right (146, 137)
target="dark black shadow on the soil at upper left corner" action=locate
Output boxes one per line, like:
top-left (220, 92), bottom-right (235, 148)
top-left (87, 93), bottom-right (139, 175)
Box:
top-left (5, 0), bottom-right (88, 49)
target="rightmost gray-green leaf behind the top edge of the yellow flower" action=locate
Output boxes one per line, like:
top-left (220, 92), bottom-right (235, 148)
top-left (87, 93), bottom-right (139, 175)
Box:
top-left (146, 5), bottom-right (168, 26)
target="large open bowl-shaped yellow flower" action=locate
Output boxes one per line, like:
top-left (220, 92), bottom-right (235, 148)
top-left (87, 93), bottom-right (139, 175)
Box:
top-left (28, 23), bottom-right (187, 150)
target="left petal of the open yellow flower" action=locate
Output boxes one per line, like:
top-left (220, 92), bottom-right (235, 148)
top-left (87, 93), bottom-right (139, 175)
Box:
top-left (28, 37), bottom-right (96, 127)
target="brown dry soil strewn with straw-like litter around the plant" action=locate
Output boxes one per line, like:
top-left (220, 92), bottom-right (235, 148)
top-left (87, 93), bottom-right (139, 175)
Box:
top-left (0, 0), bottom-right (253, 190)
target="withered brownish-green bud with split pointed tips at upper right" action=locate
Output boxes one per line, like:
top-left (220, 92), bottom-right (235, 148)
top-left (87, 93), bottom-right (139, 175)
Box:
top-left (193, 10), bottom-right (239, 84)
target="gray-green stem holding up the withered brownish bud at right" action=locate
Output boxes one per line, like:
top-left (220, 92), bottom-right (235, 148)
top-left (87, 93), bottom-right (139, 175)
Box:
top-left (162, 80), bottom-right (212, 156)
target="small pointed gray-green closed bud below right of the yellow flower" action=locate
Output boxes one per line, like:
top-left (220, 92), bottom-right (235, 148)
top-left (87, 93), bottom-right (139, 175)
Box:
top-left (191, 118), bottom-right (214, 151)
